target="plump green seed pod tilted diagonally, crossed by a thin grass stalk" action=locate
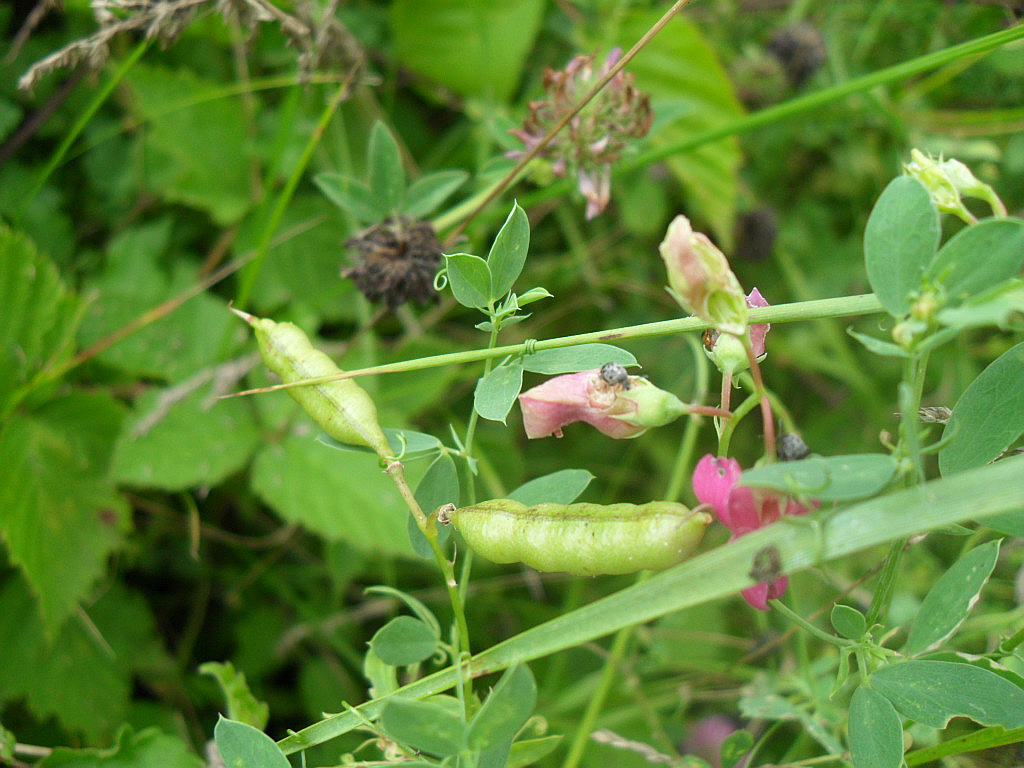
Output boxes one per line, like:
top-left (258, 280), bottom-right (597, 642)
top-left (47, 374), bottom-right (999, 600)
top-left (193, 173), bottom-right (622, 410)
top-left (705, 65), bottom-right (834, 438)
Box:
top-left (234, 310), bottom-right (391, 457)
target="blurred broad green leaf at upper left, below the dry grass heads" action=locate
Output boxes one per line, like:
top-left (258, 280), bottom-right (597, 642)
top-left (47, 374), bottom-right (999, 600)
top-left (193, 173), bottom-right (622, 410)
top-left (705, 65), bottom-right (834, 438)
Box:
top-left (125, 63), bottom-right (253, 226)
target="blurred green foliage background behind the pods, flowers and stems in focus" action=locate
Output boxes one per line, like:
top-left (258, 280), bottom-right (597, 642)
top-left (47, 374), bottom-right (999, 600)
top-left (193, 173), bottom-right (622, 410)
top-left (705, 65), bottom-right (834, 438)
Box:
top-left (0, 0), bottom-right (1024, 768)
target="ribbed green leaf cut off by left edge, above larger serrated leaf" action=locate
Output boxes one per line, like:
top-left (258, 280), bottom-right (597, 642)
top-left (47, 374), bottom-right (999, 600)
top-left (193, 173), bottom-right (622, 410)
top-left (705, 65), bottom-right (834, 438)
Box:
top-left (0, 224), bottom-right (72, 418)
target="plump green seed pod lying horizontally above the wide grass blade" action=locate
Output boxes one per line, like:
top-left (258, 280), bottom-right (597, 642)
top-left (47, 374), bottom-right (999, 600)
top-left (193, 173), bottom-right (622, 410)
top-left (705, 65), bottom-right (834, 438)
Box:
top-left (438, 499), bottom-right (711, 575)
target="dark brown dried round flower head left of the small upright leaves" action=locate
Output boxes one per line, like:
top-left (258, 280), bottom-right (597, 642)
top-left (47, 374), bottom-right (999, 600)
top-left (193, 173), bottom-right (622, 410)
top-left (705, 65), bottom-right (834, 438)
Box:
top-left (341, 216), bottom-right (441, 308)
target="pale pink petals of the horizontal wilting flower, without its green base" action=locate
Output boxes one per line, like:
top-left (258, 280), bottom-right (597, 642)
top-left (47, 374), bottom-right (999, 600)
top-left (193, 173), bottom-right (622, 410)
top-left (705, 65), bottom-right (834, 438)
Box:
top-left (519, 370), bottom-right (646, 439)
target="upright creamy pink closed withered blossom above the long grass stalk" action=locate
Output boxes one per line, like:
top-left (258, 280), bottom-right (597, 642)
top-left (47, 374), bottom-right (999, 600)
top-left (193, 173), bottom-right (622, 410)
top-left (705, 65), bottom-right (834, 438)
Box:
top-left (658, 216), bottom-right (746, 335)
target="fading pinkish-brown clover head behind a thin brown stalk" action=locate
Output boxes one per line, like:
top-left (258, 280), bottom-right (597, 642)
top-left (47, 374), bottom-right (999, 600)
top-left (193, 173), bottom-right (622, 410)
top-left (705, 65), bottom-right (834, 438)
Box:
top-left (510, 48), bottom-right (653, 219)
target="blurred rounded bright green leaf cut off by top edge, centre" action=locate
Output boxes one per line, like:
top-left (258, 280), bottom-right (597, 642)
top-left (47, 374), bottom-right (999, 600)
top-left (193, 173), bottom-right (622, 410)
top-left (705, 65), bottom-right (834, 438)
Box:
top-left (391, 0), bottom-right (544, 102)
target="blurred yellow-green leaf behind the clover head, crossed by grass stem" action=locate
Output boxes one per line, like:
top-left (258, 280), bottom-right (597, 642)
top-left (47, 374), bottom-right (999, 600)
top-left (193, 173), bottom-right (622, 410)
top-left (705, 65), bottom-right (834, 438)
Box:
top-left (612, 9), bottom-right (743, 246)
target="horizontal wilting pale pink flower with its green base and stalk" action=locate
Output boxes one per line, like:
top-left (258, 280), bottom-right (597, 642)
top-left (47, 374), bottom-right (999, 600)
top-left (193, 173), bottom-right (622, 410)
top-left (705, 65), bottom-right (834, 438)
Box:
top-left (519, 369), bottom-right (730, 439)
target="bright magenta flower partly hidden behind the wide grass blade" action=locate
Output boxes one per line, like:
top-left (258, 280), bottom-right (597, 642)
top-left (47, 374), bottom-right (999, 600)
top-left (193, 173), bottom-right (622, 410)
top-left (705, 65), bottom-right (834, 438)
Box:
top-left (693, 454), bottom-right (809, 610)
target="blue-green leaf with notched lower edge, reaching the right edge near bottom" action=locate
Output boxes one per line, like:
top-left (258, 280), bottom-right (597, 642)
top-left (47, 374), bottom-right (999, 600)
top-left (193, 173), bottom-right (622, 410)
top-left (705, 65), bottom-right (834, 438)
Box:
top-left (870, 659), bottom-right (1024, 728)
